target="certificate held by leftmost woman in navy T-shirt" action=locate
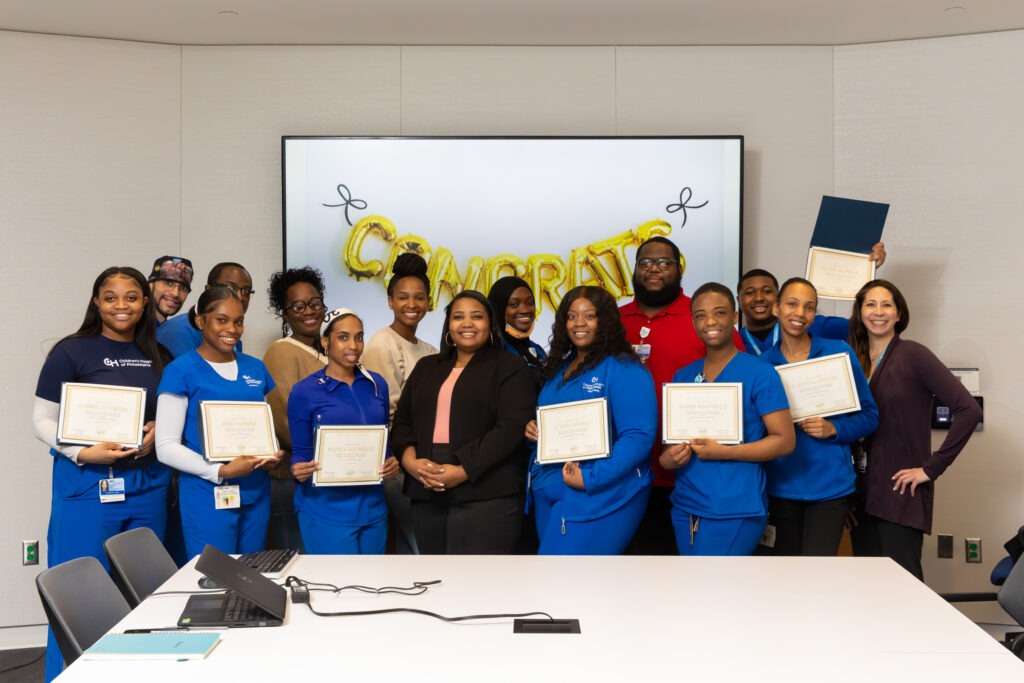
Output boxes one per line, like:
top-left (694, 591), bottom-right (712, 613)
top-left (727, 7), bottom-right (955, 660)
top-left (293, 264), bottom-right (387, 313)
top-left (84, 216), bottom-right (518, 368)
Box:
top-left (57, 382), bottom-right (145, 449)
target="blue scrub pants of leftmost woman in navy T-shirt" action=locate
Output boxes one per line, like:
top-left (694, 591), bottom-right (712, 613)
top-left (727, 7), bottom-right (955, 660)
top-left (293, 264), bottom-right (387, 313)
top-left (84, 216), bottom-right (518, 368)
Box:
top-left (46, 455), bottom-right (170, 681)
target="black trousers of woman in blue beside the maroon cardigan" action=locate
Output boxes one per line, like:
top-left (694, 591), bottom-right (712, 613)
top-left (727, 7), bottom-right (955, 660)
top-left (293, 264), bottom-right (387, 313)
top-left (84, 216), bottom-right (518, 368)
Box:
top-left (768, 496), bottom-right (851, 557)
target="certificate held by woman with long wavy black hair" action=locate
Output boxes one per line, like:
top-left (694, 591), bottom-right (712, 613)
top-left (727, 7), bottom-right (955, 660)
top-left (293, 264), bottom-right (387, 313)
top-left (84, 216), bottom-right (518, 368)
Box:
top-left (537, 398), bottom-right (611, 465)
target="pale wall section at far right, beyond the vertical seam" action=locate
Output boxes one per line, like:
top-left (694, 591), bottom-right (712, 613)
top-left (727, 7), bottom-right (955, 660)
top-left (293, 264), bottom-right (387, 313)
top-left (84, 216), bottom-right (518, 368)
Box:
top-left (835, 31), bottom-right (1024, 591)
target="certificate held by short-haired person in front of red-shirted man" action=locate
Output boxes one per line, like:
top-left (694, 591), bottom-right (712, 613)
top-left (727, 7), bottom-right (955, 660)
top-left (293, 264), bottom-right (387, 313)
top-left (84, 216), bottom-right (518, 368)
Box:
top-left (662, 382), bottom-right (743, 443)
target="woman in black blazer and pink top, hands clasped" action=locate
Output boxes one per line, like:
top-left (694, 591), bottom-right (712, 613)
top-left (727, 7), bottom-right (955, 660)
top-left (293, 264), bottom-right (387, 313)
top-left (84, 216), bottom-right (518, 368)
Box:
top-left (391, 290), bottom-right (537, 554)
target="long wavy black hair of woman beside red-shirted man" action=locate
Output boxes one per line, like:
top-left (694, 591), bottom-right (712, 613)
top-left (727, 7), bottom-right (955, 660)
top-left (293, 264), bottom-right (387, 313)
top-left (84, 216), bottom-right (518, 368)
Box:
top-left (542, 286), bottom-right (640, 380)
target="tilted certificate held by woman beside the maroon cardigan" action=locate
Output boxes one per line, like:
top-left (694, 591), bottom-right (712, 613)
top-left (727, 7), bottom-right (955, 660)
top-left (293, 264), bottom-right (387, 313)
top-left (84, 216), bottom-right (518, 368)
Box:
top-left (775, 353), bottom-right (860, 422)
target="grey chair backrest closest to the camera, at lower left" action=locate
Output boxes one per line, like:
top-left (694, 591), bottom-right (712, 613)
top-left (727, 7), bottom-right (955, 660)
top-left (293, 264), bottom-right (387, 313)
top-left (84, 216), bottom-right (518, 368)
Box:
top-left (36, 557), bottom-right (131, 665)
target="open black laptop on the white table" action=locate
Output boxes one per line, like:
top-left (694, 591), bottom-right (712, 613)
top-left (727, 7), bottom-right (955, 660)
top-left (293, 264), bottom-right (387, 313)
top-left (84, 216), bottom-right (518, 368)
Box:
top-left (178, 546), bottom-right (288, 629)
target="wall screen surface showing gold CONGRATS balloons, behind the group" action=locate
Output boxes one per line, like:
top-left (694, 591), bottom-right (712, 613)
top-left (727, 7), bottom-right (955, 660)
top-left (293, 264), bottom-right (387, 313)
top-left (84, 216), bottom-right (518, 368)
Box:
top-left (283, 136), bottom-right (742, 346)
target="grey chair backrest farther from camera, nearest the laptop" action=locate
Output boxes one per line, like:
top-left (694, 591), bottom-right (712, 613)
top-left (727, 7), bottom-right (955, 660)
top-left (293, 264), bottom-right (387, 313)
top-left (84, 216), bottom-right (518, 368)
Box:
top-left (103, 526), bottom-right (178, 607)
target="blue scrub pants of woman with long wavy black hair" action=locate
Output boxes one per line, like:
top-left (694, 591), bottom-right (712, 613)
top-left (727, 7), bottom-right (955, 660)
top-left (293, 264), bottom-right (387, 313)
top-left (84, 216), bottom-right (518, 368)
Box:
top-left (538, 486), bottom-right (650, 555)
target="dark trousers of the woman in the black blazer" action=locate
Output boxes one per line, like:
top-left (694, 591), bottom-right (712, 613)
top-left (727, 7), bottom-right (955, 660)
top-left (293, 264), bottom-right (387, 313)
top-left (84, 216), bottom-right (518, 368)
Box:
top-left (413, 495), bottom-right (524, 555)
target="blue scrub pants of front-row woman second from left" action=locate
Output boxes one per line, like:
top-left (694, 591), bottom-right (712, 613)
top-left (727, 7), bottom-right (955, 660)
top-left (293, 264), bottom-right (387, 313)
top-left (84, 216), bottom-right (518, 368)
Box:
top-left (178, 475), bottom-right (270, 558)
